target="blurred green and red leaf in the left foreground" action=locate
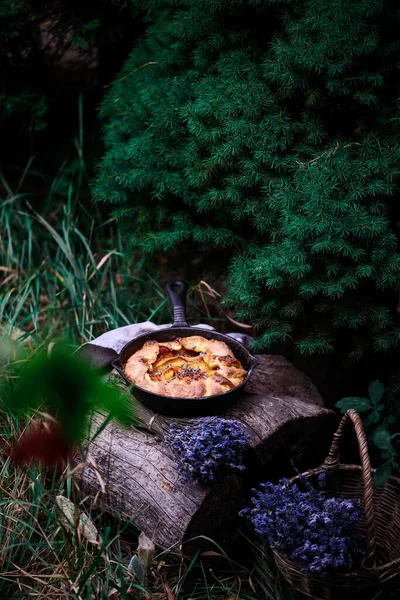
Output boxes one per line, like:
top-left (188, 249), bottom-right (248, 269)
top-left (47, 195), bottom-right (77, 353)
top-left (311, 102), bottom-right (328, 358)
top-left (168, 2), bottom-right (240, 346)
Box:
top-left (1, 343), bottom-right (134, 462)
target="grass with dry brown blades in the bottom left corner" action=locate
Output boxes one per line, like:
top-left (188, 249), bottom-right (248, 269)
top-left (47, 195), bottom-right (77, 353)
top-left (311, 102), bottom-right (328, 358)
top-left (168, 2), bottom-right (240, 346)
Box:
top-left (0, 420), bottom-right (142, 600)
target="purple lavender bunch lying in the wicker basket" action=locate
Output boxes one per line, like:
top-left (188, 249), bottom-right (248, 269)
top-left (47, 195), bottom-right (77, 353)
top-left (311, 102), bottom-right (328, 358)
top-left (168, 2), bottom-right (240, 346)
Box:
top-left (240, 474), bottom-right (363, 576)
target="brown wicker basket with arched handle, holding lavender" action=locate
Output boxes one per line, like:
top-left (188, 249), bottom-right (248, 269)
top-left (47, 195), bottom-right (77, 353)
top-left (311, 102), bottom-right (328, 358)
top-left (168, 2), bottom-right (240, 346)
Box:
top-left (273, 410), bottom-right (400, 600)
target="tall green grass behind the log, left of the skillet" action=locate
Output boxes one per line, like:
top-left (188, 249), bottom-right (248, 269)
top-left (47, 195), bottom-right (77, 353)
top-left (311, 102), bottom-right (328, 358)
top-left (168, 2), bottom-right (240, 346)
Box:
top-left (0, 179), bottom-right (167, 343)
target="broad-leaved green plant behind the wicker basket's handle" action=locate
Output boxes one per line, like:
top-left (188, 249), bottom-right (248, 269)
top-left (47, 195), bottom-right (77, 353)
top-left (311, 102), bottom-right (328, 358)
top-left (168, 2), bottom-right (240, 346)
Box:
top-left (336, 380), bottom-right (400, 486)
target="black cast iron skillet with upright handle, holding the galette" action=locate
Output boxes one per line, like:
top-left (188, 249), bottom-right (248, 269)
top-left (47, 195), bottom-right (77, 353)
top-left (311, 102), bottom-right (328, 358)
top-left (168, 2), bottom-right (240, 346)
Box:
top-left (112, 281), bottom-right (259, 416)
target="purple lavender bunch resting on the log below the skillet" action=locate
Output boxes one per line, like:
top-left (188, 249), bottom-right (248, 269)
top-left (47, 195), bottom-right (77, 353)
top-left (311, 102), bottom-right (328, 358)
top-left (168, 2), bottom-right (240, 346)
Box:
top-left (166, 417), bottom-right (249, 484)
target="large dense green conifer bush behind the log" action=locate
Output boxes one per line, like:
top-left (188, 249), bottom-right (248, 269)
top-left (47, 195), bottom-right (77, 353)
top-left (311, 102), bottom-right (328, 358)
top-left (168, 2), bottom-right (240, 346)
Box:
top-left (94, 0), bottom-right (400, 359)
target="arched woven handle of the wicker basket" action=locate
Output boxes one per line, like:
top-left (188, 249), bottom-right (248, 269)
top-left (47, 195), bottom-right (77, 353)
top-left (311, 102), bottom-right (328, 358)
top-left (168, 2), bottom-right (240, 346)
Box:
top-left (322, 409), bottom-right (376, 573)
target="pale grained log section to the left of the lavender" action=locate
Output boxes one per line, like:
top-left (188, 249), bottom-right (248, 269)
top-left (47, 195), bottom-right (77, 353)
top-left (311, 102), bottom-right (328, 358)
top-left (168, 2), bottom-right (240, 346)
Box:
top-left (79, 417), bottom-right (241, 548)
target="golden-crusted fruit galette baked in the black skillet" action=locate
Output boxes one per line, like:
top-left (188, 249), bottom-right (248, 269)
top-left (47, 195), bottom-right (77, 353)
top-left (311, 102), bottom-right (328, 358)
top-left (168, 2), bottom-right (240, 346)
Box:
top-left (124, 335), bottom-right (246, 398)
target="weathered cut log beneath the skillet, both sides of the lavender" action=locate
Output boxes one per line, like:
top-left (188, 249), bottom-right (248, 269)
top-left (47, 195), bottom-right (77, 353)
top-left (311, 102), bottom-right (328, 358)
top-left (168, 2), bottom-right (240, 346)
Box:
top-left (79, 356), bottom-right (333, 548)
